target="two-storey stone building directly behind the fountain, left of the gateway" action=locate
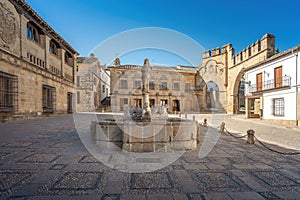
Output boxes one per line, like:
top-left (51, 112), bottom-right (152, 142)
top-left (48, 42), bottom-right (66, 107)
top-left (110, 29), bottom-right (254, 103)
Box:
top-left (108, 58), bottom-right (203, 113)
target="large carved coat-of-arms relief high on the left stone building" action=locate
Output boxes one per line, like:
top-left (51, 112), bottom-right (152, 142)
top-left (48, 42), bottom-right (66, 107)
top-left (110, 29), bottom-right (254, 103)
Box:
top-left (0, 2), bottom-right (18, 44)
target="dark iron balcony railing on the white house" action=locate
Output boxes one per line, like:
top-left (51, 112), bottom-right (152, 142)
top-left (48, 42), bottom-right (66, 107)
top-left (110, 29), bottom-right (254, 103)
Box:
top-left (249, 76), bottom-right (291, 93)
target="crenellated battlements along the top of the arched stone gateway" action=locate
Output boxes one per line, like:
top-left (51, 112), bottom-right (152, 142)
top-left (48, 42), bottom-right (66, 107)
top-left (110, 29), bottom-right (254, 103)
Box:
top-left (202, 33), bottom-right (275, 65)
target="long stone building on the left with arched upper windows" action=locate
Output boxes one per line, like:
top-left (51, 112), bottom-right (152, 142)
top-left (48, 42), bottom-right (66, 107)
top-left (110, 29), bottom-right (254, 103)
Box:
top-left (0, 0), bottom-right (78, 119)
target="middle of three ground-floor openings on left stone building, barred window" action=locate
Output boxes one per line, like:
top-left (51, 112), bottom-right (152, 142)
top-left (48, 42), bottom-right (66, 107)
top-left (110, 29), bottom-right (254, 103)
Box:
top-left (42, 85), bottom-right (56, 113)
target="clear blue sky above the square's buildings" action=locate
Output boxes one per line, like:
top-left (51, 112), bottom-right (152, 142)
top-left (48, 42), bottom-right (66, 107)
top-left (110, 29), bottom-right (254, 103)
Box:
top-left (26, 0), bottom-right (300, 65)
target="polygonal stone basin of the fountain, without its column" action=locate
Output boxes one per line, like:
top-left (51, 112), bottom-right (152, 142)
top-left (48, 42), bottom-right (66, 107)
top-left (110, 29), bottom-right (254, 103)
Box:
top-left (91, 118), bottom-right (200, 152)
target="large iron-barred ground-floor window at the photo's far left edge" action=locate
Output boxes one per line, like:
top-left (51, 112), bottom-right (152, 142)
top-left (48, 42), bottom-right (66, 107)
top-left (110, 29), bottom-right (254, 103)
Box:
top-left (0, 71), bottom-right (18, 112)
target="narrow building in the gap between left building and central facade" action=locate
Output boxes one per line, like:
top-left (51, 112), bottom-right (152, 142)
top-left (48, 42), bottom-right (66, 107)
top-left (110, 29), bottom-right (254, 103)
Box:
top-left (76, 54), bottom-right (110, 112)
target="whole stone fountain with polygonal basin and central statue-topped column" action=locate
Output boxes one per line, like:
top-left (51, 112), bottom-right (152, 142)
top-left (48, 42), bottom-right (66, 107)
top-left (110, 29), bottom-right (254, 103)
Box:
top-left (91, 59), bottom-right (199, 152)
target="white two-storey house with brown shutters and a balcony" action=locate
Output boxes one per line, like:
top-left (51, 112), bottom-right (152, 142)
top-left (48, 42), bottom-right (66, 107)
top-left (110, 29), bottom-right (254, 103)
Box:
top-left (244, 46), bottom-right (300, 126)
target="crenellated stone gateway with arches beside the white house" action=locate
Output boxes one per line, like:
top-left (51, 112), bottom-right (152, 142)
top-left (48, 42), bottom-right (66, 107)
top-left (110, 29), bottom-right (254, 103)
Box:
top-left (199, 34), bottom-right (275, 113)
